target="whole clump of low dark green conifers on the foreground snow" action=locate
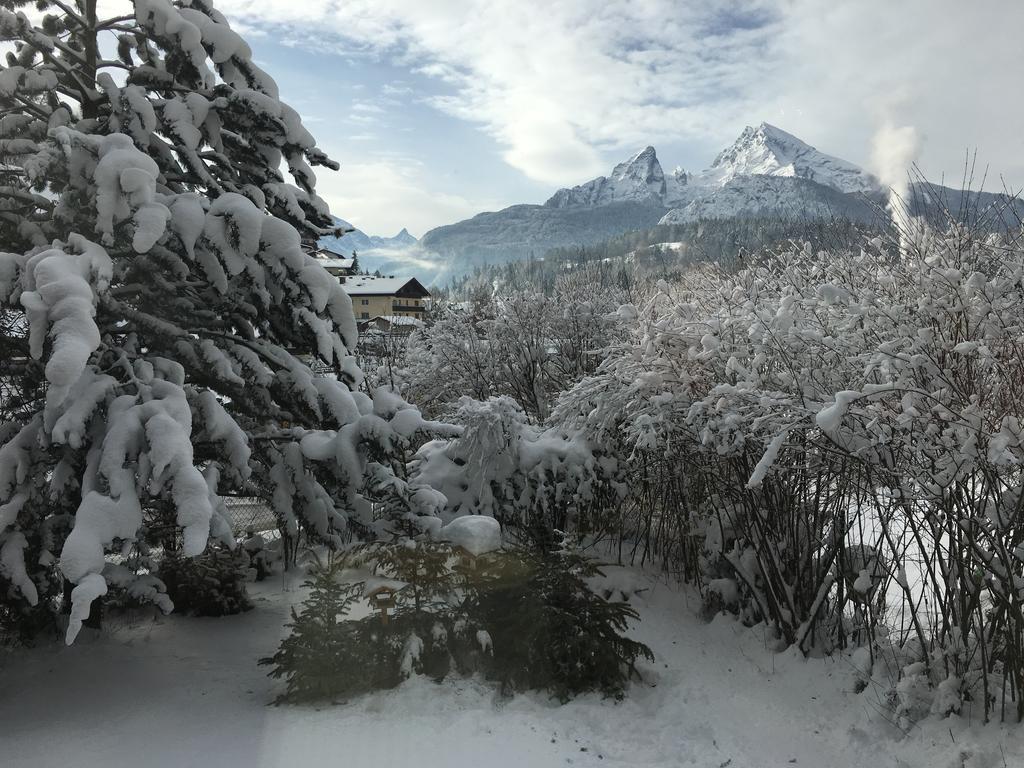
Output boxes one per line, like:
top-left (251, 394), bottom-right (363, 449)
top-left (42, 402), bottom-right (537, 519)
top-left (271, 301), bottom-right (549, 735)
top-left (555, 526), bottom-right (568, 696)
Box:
top-left (260, 539), bottom-right (652, 702)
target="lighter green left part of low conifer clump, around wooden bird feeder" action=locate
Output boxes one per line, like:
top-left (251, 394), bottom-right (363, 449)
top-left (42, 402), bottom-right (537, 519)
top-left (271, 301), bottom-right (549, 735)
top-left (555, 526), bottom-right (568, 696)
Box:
top-left (260, 536), bottom-right (491, 702)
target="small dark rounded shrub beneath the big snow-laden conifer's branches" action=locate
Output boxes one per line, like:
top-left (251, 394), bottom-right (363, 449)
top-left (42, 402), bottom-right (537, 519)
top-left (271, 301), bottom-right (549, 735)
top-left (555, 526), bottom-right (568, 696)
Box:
top-left (157, 544), bottom-right (252, 616)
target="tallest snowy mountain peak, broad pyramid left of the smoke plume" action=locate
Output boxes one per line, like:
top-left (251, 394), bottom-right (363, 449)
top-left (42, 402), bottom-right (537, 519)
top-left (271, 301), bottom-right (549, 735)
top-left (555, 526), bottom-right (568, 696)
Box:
top-left (706, 123), bottom-right (879, 193)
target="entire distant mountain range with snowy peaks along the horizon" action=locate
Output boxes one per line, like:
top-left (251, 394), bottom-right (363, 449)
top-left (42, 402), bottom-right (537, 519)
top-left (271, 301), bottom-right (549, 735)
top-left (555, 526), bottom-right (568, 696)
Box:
top-left (328, 123), bottom-right (1024, 280)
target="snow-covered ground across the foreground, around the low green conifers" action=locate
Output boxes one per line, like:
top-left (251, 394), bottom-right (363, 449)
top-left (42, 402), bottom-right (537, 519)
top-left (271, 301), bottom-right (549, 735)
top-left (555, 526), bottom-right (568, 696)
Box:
top-left (0, 573), bottom-right (1024, 768)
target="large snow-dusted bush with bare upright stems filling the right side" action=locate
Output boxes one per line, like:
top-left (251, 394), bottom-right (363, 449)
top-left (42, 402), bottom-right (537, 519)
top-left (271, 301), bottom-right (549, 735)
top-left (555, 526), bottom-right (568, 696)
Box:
top-left (552, 221), bottom-right (1024, 729)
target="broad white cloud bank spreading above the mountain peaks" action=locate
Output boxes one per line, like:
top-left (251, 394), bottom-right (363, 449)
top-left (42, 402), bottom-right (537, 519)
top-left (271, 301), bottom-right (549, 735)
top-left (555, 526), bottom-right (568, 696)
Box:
top-left (218, 0), bottom-right (1024, 192)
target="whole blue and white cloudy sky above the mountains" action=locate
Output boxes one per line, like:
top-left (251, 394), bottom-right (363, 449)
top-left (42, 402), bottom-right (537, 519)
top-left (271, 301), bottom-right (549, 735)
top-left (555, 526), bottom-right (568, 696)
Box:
top-left (209, 0), bottom-right (1024, 237)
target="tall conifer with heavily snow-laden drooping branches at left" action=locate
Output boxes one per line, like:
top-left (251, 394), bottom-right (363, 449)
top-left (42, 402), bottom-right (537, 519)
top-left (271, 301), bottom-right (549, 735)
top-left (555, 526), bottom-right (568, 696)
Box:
top-left (0, 0), bottom-right (448, 642)
